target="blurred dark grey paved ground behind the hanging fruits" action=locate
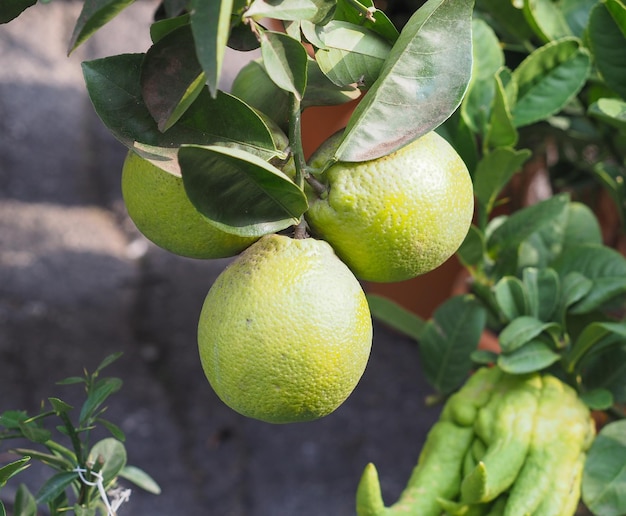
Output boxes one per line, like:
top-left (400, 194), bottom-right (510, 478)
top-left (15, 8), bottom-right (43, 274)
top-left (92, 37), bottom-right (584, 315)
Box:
top-left (0, 1), bottom-right (438, 516)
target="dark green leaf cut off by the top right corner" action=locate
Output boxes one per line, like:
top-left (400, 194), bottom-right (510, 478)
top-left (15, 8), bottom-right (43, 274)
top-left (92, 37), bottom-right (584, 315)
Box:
top-left (588, 2), bottom-right (626, 98)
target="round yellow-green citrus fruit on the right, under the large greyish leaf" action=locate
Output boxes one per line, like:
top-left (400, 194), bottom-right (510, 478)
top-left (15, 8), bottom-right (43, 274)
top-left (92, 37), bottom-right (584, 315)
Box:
top-left (305, 132), bottom-right (474, 282)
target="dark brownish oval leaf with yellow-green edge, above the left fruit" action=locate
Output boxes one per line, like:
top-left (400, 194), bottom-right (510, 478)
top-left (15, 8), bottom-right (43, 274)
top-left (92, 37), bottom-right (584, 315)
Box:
top-left (141, 25), bottom-right (205, 131)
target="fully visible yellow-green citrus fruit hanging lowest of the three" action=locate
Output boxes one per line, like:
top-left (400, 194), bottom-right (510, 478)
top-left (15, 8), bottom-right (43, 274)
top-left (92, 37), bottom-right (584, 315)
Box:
top-left (198, 235), bottom-right (372, 423)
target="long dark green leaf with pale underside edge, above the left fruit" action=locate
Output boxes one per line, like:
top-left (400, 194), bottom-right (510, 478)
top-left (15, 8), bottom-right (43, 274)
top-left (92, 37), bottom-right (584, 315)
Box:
top-left (82, 54), bottom-right (277, 176)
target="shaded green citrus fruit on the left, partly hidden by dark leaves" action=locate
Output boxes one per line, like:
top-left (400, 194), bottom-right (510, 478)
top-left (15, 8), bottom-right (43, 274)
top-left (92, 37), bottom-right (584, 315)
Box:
top-left (122, 151), bottom-right (257, 259)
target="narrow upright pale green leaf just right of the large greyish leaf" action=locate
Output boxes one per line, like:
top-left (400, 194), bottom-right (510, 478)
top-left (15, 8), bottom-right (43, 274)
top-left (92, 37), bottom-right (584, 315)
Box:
top-left (461, 18), bottom-right (504, 136)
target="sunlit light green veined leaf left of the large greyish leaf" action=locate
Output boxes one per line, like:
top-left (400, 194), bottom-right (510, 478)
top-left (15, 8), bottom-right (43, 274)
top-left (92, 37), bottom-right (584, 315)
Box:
top-left (303, 21), bottom-right (391, 89)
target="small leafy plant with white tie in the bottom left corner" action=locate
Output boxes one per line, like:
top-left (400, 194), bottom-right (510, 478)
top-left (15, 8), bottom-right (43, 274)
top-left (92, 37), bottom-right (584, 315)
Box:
top-left (0, 353), bottom-right (161, 516)
